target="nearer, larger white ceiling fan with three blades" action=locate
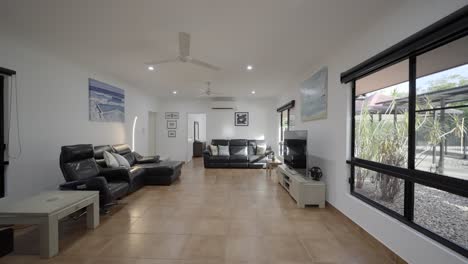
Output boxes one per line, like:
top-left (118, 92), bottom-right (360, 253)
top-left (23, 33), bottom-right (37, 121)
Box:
top-left (146, 32), bottom-right (221, 71)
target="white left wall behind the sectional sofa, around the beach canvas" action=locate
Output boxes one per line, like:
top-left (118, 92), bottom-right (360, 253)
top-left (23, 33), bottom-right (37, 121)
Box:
top-left (0, 34), bottom-right (156, 199)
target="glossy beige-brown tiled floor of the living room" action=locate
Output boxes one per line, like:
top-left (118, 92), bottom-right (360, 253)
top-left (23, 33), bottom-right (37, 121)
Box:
top-left (0, 159), bottom-right (400, 264)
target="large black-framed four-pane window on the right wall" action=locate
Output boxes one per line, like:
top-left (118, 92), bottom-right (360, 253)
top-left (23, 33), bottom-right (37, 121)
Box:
top-left (342, 6), bottom-right (468, 256)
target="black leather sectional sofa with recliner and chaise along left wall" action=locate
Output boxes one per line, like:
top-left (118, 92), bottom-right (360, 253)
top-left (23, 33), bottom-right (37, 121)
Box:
top-left (60, 144), bottom-right (183, 207)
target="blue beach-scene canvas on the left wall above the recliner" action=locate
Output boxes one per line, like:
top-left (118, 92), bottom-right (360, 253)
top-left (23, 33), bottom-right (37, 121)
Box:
top-left (88, 79), bottom-right (125, 123)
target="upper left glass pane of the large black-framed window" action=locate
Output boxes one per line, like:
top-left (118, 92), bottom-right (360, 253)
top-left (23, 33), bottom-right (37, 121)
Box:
top-left (354, 61), bottom-right (409, 167)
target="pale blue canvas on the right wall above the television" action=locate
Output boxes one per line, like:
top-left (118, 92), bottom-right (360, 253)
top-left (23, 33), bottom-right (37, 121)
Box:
top-left (300, 67), bottom-right (328, 121)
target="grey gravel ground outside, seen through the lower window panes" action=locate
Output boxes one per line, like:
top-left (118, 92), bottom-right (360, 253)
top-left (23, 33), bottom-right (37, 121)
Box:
top-left (355, 180), bottom-right (468, 249)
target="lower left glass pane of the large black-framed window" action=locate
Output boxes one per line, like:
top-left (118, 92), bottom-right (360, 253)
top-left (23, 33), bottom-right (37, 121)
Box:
top-left (354, 167), bottom-right (404, 215)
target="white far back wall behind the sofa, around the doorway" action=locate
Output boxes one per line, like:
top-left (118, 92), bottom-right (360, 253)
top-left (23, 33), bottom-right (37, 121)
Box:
top-left (158, 98), bottom-right (278, 160)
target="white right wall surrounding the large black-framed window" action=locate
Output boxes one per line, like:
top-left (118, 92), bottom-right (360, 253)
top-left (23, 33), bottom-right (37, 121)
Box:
top-left (278, 0), bottom-right (468, 264)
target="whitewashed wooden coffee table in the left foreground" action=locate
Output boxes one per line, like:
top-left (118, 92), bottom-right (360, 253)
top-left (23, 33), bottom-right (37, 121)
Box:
top-left (0, 191), bottom-right (99, 258)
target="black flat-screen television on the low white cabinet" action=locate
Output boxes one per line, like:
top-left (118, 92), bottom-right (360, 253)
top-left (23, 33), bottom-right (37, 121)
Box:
top-left (283, 130), bottom-right (307, 175)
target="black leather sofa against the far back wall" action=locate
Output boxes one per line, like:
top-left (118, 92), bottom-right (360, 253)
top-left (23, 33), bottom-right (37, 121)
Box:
top-left (203, 139), bottom-right (272, 168)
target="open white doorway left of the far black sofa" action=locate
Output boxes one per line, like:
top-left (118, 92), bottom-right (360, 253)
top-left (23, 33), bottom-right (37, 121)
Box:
top-left (186, 113), bottom-right (206, 162)
